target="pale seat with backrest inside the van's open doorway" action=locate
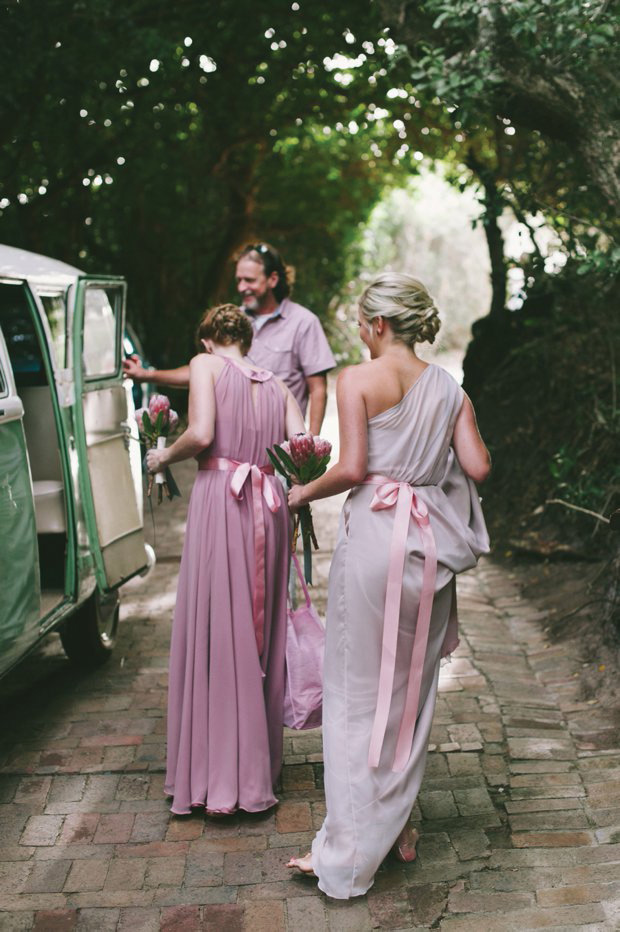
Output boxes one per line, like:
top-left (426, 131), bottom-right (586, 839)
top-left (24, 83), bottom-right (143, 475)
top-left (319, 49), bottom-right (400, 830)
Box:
top-left (18, 385), bottom-right (67, 534)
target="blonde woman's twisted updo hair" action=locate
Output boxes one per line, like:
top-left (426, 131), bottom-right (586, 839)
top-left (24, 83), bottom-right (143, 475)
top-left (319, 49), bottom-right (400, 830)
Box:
top-left (360, 272), bottom-right (441, 349)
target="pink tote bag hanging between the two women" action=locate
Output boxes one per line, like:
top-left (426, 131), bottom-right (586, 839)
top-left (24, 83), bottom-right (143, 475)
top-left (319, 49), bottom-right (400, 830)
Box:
top-left (284, 554), bottom-right (325, 731)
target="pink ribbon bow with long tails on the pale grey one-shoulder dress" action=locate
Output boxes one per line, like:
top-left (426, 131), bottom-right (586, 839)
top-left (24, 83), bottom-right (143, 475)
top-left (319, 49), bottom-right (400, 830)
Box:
top-left (364, 474), bottom-right (437, 773)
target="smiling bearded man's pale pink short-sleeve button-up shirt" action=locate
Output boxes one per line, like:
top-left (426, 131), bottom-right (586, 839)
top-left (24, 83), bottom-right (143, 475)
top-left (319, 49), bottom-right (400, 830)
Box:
top-left (248, 298), bottom-right (336, 416)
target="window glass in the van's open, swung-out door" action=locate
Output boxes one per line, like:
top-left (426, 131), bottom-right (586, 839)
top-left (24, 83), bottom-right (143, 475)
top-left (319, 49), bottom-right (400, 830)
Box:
top-left (82, 285), bottom-right (121, 379)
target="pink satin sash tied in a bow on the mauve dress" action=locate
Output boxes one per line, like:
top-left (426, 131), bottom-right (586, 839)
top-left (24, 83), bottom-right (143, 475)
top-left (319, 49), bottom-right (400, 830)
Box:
top-left (198, 456), bottom-right (280, 656)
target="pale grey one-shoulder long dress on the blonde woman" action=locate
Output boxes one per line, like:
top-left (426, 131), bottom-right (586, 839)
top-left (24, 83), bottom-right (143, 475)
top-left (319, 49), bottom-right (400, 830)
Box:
top-left (312, 365), bottom-right (488, 899)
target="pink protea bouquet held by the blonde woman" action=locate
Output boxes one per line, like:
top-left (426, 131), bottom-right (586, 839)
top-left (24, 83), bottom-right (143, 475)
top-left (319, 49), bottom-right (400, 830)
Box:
top-left (267, 433), bottom-right (332, 584)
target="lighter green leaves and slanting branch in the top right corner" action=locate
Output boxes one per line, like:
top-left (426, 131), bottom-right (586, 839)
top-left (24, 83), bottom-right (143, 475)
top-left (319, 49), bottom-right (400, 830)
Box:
top-left (380, 0), bottom-right (620, 212)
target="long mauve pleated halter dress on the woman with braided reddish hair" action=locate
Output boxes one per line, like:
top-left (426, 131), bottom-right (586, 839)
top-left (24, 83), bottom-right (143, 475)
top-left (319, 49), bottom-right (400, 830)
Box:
top-left (165, 357), bottom-right (291, 814)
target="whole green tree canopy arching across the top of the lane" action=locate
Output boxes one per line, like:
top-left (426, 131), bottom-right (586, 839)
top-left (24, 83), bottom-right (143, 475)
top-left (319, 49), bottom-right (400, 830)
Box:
top-left (0, 0), bottom-right (620, 362)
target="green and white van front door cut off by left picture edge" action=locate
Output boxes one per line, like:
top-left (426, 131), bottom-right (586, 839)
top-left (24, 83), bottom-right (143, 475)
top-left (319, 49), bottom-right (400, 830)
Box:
top-left (0, 324), bottom-right (41, 672)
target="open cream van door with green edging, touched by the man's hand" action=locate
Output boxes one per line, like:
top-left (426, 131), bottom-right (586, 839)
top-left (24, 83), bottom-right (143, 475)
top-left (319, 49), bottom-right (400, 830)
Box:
top-left (72, 276), bottom-right (147, 592)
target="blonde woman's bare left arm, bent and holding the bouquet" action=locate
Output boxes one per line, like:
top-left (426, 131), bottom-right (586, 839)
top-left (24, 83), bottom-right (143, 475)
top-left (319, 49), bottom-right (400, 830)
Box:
top-left (288, 366), bottom-right (368, 509)
